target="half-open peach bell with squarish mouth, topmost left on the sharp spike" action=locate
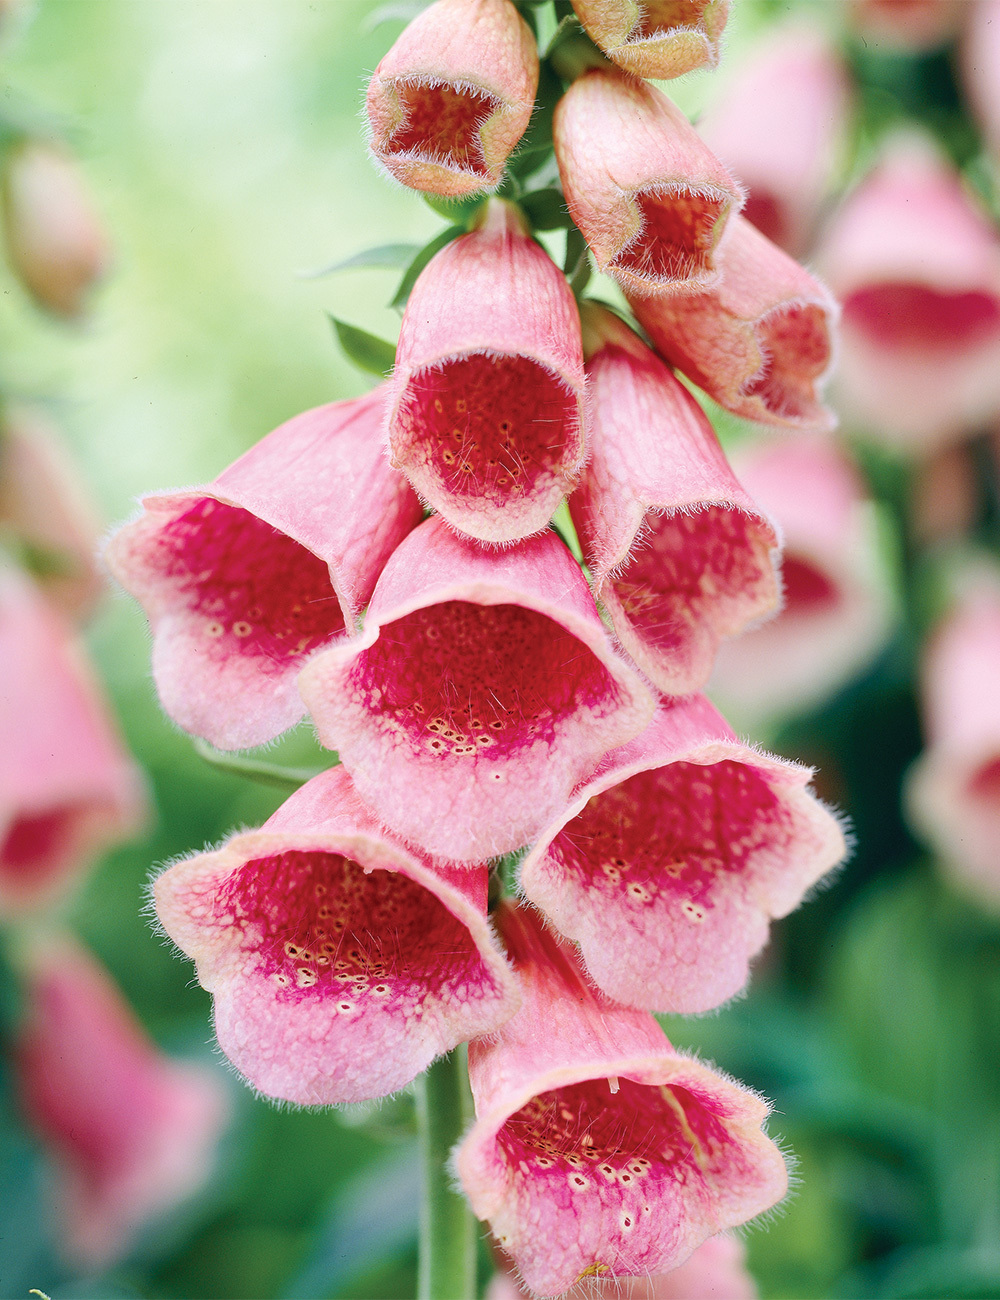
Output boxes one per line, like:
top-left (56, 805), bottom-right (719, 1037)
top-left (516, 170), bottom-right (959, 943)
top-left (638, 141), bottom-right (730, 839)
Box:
top-left (368, 0), bottom-right (538, 198)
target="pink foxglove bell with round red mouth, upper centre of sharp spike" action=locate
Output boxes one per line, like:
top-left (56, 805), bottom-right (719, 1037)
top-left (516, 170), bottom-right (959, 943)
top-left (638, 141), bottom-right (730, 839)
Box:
top-left (389, 199), bottom-right (584, 542)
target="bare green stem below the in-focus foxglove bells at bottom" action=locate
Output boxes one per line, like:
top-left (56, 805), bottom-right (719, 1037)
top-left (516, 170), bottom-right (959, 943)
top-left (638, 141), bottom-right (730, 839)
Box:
top-left (416, 1048), bottom-right (476, 1300)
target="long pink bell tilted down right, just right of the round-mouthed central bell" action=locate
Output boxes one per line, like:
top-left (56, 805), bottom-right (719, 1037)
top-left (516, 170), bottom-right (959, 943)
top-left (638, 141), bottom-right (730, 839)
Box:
top-left (570, 304), bottom-right (779, 696)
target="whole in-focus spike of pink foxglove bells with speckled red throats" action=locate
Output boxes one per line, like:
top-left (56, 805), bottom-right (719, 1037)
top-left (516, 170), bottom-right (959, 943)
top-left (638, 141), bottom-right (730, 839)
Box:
top-left (108, 0), bottom-right (844, 1295)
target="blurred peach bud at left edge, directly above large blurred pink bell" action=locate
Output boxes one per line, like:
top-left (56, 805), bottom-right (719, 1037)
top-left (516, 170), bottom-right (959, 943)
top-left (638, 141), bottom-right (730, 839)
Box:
top-left (0, 410), bottom-right (101, 618)
